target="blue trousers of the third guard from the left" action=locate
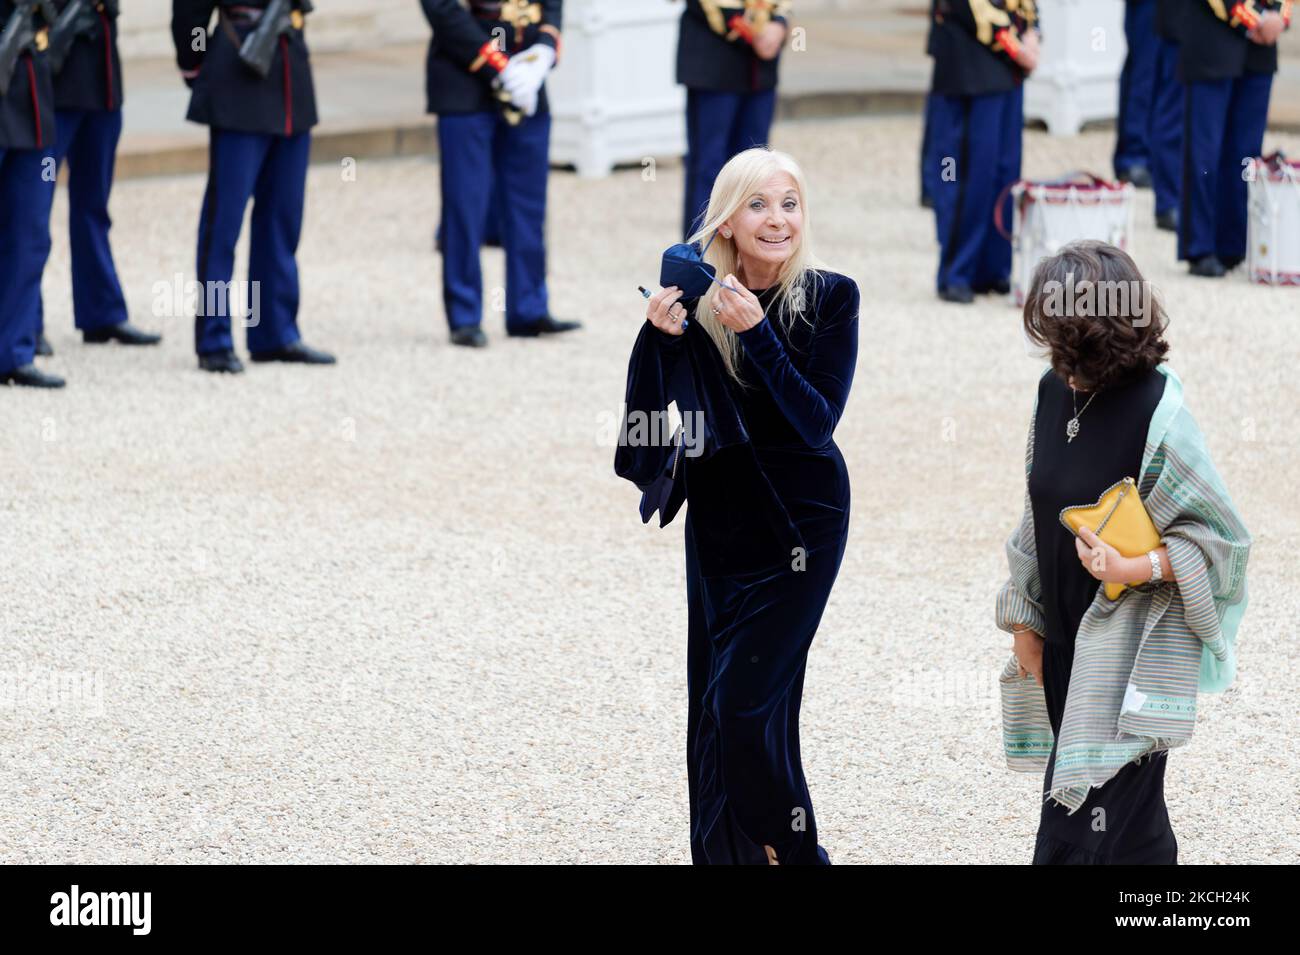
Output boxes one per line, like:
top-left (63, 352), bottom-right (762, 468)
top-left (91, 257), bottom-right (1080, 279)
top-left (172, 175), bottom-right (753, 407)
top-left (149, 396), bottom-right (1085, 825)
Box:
top-left (195, 127), bottom-right (311, 355)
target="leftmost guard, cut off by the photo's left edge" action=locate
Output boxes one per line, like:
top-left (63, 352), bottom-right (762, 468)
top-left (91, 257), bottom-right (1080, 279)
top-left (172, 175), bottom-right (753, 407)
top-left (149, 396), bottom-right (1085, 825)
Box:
top-left (0, 0), bottom-right (64, 388)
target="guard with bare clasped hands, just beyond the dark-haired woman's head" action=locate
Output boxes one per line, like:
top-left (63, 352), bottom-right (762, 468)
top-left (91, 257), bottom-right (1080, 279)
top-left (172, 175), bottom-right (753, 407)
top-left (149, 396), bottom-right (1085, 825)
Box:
top-left (926, 0), bottom-right (1039, 303)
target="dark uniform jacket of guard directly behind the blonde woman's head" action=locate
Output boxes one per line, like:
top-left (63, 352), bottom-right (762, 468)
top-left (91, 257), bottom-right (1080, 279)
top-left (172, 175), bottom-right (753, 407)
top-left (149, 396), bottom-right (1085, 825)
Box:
top-left (677, 0), bottom-right (790, 92)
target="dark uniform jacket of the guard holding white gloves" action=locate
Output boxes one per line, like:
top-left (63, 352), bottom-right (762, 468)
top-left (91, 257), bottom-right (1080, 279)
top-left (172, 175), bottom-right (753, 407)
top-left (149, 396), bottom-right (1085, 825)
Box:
top-left (420, 0), bottom-right (564, 113)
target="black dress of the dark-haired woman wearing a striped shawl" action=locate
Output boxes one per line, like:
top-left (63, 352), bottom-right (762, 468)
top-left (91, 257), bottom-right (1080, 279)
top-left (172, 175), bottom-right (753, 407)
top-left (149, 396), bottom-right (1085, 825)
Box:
top-left (1030, 369), bottom-right (1178, 865)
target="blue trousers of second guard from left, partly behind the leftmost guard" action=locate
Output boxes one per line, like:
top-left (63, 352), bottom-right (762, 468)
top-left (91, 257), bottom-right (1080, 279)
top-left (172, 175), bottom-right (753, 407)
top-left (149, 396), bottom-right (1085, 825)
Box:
top-left (38, 109), bottom-right (127, 330)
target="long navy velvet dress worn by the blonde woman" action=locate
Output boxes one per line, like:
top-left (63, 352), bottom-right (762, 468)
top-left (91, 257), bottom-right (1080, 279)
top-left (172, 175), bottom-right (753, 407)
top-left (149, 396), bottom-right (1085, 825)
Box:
top-left (660, 272), bottom-right (859, 865)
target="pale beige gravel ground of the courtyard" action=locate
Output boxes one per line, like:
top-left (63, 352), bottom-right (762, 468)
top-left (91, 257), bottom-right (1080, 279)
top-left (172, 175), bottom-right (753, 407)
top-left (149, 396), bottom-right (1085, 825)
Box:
top-left (0, 117), bottom-right (1300, 863)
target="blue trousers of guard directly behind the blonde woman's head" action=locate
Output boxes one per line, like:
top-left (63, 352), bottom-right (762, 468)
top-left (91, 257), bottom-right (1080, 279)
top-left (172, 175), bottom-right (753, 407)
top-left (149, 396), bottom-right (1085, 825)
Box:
top-left (681, 88), bottom-right (776, 238)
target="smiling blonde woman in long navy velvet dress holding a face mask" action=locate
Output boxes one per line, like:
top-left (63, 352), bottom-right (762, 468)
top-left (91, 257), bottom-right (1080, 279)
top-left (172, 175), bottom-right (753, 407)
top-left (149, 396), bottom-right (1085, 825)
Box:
top-left (633, 148), bottom-right (858, 865)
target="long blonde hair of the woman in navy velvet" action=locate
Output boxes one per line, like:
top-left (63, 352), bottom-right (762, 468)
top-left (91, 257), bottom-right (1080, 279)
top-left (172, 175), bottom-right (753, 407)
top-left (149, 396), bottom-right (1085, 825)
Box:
top-left (686, 146), bottom-right (820, 381)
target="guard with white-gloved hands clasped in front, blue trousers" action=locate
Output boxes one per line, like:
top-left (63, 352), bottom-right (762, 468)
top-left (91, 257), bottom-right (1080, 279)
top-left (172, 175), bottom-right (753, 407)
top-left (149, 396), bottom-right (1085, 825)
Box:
top-left (421, 0), bottom-right (581, 348)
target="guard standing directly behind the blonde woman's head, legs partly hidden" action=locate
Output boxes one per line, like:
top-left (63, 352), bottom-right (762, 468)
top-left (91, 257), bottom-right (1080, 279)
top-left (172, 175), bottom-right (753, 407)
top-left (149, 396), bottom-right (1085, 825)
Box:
top-left (677, 0), bottom-right (790, 238)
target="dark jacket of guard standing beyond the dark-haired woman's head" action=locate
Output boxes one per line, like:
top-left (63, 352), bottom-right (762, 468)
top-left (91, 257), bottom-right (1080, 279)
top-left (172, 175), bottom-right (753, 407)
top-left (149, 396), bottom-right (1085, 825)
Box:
top-left (930, 0), bottom-right (1037, 96)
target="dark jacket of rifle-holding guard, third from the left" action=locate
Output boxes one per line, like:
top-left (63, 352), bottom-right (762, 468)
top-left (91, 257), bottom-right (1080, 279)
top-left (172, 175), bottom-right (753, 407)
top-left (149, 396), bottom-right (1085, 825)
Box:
top-left (172, 0), bottom-right (316, 136)
